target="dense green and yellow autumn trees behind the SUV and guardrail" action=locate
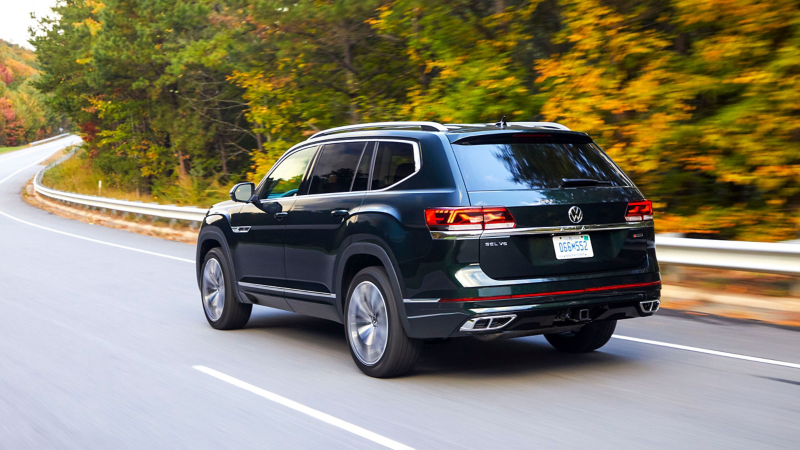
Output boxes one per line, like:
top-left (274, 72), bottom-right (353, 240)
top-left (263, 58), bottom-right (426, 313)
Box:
top-left (29, 0), bottom-right (800, 240)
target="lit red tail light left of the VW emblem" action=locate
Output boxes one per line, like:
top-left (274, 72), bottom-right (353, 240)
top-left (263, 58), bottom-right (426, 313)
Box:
top-left (425, 207), bottom-right (517, 231)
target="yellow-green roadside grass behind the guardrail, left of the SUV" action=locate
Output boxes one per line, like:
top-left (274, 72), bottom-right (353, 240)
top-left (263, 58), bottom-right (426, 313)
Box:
top-left (42, 149), bottom-right (228, 208)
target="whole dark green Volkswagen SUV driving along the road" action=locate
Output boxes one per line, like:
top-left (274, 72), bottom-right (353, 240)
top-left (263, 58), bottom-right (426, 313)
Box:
top-left (197, 121), bottom-right (661, 377)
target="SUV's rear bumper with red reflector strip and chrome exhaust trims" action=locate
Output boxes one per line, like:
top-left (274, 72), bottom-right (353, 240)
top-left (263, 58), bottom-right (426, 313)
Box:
top-left (404, 273), bottom-right (661, 339)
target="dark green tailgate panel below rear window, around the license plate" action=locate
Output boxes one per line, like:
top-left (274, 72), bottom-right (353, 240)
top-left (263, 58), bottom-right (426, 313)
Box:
top-left (470, 187), bottom-right (652, 280)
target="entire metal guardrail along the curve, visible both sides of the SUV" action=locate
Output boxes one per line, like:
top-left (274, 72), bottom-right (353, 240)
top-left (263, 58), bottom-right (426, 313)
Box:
top-left (34, 135), bottom-right (800, 275)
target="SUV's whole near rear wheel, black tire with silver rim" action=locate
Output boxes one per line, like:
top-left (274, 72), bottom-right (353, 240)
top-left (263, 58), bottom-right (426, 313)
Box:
top-left (344, 267), bottom-right (422, 378)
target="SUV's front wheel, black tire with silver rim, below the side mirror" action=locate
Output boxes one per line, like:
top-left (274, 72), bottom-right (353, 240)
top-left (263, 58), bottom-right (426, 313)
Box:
top-left (200, 247), bottom-right (253, 330)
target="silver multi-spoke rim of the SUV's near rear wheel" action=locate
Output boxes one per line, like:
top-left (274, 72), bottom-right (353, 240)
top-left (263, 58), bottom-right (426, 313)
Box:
top-left (347, 281), bottom-right (389, 366)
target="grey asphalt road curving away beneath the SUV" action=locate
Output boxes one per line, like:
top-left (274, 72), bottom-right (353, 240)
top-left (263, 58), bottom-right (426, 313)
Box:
top-left (0, 141), bottom-right (800, 449)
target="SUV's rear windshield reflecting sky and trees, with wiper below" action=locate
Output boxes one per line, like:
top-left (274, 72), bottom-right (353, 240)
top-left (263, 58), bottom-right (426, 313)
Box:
top-left (453, 142), bottom-right (630, 191)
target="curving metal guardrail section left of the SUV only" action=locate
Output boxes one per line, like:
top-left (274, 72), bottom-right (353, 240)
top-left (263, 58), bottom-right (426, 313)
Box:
top-left (33, 137), bottom-right (208, 222)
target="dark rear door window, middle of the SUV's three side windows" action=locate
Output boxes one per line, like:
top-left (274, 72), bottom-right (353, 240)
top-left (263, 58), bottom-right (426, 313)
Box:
top-left (308, 142), bottom-right (367, 195)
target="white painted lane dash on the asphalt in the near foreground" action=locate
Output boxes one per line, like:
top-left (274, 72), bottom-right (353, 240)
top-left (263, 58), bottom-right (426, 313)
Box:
top-left (192, 366), bottom-right (413, 450)
